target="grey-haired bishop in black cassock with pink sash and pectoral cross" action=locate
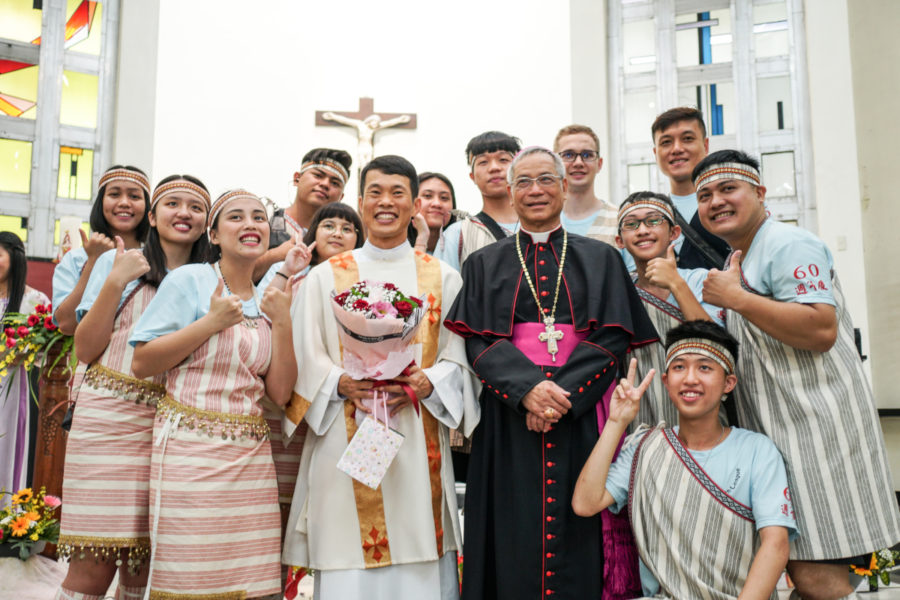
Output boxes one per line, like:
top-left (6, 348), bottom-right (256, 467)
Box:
top-left (444, 147), bottom-right (656, 600)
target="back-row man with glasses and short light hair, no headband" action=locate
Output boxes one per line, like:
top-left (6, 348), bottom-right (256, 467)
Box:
top-left (553, 125), bottom-right (616, 244)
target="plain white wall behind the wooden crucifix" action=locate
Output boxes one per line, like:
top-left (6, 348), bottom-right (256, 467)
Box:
top-left (118, 0), bottom-right (572, 216)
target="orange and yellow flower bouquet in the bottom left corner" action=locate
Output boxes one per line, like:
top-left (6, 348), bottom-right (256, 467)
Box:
top-left (0, 488), bottom-right (62, 560)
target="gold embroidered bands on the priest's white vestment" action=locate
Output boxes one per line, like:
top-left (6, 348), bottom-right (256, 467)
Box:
top-left (328, 250), bottom-right (444, 568)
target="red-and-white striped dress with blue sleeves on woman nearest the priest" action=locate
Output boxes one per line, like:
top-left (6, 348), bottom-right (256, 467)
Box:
top-left (131, 265), bottom-right (281, 600)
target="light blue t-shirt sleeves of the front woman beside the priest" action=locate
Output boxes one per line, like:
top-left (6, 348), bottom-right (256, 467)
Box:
top-left (128, 263), bottom-right (261, 346)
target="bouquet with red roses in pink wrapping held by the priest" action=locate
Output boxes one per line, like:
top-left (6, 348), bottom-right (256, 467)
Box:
top-left (331, 280), bottom-right (428, 380)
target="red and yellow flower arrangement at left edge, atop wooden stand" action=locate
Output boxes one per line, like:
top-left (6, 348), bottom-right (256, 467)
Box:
top-left (0, 304), bottom-right (75, 379)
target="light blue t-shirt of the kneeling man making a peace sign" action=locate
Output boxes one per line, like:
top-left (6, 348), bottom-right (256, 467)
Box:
top-left (606, 426), bottom-right (797, 596)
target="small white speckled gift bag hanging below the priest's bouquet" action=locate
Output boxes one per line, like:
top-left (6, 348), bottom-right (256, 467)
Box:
top-left (337, 391), bottom-right (403, 490)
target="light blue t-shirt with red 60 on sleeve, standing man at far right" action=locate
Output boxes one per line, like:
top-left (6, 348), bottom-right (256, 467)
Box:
top-left (741, 219), bottom-right (836, 306)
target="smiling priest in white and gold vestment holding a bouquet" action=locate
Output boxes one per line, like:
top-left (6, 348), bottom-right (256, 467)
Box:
top-left (283, 156), bottom-right (479, 600)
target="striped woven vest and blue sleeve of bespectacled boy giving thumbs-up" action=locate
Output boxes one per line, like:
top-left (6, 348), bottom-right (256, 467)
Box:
top-left (630, 269), bottom-right (722, 430)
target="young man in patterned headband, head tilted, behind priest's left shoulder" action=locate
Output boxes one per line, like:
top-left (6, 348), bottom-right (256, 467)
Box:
top-left (253, 148), bottom-right (354, 280)
